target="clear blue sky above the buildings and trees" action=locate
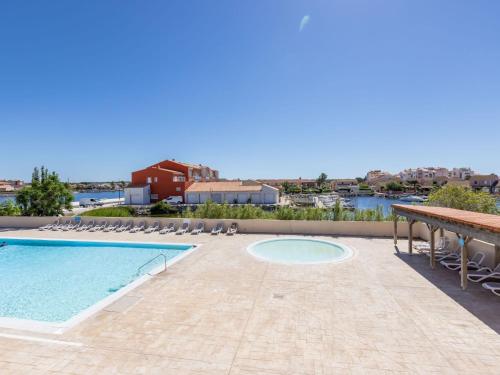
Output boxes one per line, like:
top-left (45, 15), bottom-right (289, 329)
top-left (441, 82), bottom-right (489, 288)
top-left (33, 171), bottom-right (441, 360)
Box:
top-left (0, 0), bottom-right (500, 181)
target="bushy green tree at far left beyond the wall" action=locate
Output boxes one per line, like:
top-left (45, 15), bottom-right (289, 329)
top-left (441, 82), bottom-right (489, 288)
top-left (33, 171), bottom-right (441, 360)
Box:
top-left (16, 166), bottom-right (73, 216)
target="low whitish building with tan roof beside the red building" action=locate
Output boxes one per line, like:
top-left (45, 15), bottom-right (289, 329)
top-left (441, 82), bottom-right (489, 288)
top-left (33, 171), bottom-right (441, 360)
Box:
top-left (185, 181), bottom-right (279, 204)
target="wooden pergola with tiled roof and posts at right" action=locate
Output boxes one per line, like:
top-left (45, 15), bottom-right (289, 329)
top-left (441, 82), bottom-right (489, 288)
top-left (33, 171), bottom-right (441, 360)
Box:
top-left (392, 204), bottom-right (500, 289)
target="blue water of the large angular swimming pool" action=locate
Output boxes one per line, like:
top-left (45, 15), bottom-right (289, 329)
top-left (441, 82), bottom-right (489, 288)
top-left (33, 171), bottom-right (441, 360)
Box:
top-left (0, 238), bottom-right (191, 322)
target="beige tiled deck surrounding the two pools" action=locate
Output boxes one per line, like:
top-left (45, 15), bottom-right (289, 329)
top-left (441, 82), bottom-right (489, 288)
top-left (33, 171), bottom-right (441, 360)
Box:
top-left (0, 231), bottom-right (500, 375)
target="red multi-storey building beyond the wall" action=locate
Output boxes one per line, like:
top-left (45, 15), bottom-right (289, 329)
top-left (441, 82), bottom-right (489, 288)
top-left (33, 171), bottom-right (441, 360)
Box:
top-left (132, 159), bottom-right (219, 202)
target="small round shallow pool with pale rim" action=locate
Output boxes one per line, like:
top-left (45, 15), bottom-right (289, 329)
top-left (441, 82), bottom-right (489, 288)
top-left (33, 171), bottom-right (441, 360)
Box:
top-left (247, 238), bottom-right (353, 264)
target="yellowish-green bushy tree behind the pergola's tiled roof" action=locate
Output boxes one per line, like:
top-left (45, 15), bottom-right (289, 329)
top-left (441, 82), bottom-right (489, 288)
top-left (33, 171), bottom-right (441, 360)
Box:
top-left (427, 185), bottom-right (497, 214)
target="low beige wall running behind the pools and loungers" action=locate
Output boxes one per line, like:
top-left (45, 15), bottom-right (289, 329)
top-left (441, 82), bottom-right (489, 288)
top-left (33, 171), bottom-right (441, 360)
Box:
top-left (0, 216), bottom-right (408, 237)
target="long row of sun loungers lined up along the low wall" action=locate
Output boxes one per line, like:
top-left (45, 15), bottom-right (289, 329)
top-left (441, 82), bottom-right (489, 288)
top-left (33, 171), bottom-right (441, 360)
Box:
top-left (38, 220), bottom-right (238, 235)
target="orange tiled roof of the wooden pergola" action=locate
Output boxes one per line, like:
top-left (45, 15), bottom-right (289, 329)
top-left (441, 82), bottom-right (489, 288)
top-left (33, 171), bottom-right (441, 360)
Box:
top-left (392, 204), bottom-right (500, 233)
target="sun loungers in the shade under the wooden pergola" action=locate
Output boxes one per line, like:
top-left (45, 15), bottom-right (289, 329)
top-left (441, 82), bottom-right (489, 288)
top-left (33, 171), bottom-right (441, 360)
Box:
top-left (414, 237), bottom-right (500, 296)
